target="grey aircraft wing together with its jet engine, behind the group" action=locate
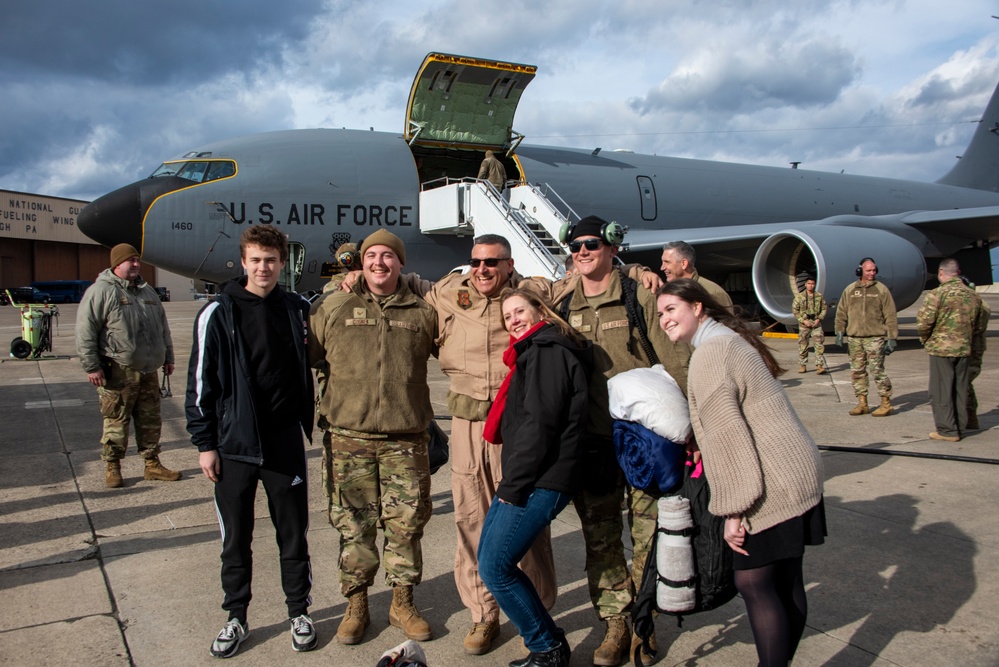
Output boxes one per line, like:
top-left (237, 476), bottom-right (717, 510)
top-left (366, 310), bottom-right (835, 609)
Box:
top-left (625, 206), bottom-right (999, 326)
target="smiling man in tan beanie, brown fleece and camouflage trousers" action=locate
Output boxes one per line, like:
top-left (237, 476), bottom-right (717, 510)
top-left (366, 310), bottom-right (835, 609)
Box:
top-left (309, 230), bottom-right (437, 644)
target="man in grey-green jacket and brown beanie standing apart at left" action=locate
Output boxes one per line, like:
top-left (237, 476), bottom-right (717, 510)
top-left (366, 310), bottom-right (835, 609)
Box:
top-left (76, 243), bottom-right (181, 488)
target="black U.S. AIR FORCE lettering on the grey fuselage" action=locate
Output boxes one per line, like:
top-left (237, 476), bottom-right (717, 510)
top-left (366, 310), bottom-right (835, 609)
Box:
top-left (211, 202), bottom-right (416, 227)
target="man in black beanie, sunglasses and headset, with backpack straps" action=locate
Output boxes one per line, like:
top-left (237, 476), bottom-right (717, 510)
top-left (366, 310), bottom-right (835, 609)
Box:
top-left (556, 216), bottom-right (690, 665)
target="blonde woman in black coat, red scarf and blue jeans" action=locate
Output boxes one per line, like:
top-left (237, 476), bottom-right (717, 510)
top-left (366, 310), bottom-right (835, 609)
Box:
top-left (479, 290), bottom-right (592, 667)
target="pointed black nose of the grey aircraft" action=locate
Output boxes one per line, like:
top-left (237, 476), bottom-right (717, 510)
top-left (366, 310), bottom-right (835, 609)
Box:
top-left (76, 176), bottom-right (193, 251)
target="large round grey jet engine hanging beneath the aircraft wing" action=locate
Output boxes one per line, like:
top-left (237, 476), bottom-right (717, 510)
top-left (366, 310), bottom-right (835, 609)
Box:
top-left (753, 225), bottom-right (927, 331)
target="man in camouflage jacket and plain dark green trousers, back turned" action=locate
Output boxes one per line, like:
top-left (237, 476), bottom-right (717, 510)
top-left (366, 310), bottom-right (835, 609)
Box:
top-left (916, 259), bottom-right (988, 442)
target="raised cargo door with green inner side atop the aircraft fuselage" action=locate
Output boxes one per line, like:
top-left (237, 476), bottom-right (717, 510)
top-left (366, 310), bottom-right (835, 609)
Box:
top-left (405, 53), bottom-right (537, 155)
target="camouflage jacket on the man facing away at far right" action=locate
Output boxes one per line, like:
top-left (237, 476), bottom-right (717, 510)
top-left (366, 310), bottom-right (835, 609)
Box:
top-left (916, 276), bottom-right (988, 357)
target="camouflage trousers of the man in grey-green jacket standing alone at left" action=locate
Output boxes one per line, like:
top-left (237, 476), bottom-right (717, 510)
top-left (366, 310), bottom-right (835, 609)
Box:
top-left (97, 361), bottom-right (162, 461)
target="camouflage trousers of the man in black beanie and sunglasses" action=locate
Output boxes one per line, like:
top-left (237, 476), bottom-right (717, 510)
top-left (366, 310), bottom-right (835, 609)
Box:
top-left (572, 471), bottom-right (659, 620)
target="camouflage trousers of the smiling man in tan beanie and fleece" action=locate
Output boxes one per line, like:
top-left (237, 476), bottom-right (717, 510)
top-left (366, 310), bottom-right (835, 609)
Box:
top-left (323, 432), bottom-right (431, 597)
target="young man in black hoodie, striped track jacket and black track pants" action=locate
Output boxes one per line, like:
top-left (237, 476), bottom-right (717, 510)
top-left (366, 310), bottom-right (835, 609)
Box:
top-left (185, 225), bottom-right (318, 658)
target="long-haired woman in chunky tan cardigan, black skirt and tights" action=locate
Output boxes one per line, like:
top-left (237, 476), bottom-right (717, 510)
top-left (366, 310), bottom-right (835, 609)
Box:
top-left (656, 279), bottom-right (826, 667)
